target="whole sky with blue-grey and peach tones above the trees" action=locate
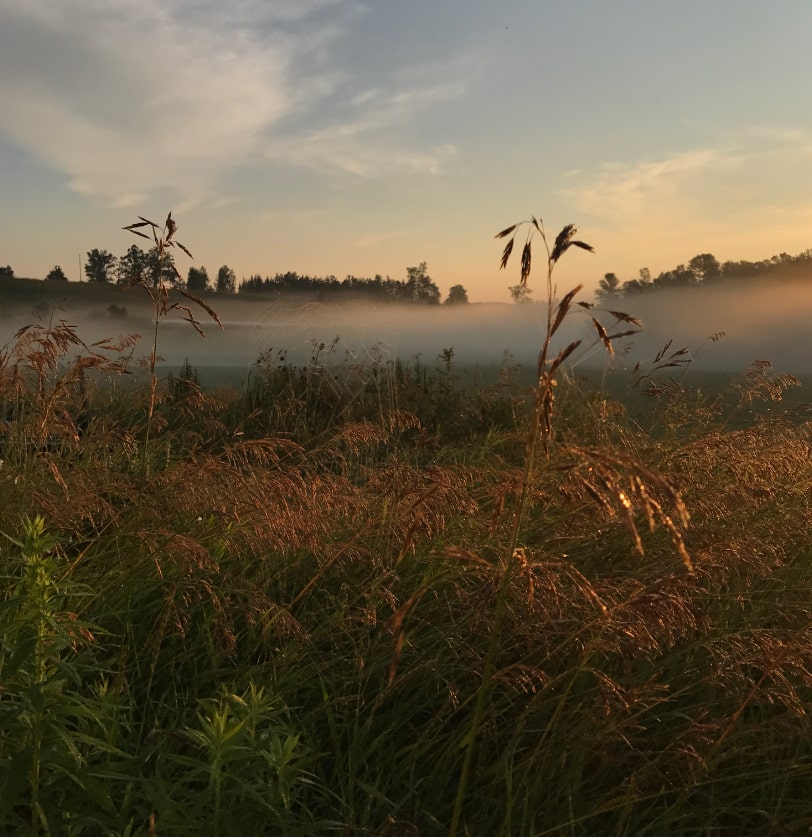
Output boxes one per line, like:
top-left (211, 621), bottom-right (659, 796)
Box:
top-left (0, 0), bottom-right (812, 302)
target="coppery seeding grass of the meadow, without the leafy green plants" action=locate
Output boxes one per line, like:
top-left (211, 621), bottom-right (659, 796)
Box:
top-left (0, 346), bottom-right (812, 833)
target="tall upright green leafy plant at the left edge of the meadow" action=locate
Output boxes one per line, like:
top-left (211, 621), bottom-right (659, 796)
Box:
top-left (0, 517), bottom-right (126, 834)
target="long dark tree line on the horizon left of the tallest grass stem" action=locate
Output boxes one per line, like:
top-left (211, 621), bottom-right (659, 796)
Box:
top-left (0, 251), bottom-right (468, 305)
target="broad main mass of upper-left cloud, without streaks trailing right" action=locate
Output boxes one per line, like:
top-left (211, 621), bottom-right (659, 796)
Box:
top-left (0, 0), bottom-right (356, 205)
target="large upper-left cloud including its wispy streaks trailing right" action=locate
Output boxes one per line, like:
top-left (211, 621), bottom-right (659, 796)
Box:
top-left (0, 0), bottom-right (470, 209)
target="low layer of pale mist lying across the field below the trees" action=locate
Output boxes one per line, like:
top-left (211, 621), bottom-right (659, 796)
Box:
top-left (0, 283), bottom-right (812, 374)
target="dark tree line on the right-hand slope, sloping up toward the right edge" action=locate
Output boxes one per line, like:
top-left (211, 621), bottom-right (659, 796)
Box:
top-left (595, 250), bottom-right (812, 302)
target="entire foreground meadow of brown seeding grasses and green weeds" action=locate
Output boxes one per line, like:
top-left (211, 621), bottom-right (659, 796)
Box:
top-left (0, 219), bottom-right (812, 835)
